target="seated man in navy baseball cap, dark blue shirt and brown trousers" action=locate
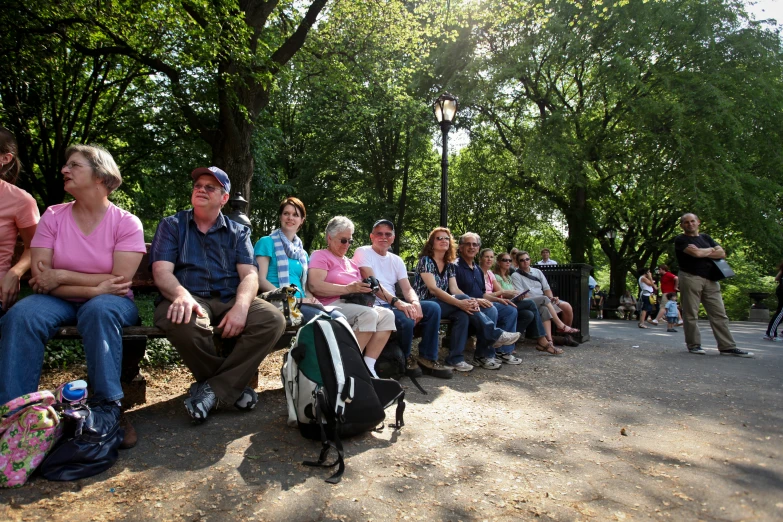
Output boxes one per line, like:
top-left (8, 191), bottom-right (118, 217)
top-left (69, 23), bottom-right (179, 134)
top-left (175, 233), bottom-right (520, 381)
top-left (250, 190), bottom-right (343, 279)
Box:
top-left (150, 167), bottom-right (285, 422)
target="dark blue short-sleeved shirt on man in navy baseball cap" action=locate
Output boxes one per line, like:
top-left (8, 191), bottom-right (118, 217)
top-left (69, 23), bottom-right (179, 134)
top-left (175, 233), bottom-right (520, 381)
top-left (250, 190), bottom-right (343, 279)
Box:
top-left (150, 210), bottom-right (258, 303)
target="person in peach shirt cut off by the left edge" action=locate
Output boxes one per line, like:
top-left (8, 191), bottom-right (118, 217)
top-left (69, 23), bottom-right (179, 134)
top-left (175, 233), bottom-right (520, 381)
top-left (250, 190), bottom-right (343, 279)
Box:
top-left (0, 127), bottom-right (40, 317)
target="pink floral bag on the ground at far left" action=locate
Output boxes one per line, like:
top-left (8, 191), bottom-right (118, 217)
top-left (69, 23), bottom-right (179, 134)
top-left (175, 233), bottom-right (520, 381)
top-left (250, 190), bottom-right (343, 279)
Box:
top-left (0, 391), bottom-right (62, 488)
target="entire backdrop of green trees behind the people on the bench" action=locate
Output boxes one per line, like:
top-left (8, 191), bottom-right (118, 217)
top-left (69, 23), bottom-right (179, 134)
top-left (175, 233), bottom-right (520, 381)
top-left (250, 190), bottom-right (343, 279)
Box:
top-left (0, 0), bottom-right (783, 292)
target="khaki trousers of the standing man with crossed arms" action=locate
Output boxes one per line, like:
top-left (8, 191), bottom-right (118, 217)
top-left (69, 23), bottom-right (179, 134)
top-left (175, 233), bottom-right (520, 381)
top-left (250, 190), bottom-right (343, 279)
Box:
top-left (678, 272), bottom-right (737, 351)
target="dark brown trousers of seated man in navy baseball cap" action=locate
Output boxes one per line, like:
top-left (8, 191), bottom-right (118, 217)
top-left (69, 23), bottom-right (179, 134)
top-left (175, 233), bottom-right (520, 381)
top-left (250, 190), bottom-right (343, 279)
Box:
top-left (155, 296), bottom-right (285, 404)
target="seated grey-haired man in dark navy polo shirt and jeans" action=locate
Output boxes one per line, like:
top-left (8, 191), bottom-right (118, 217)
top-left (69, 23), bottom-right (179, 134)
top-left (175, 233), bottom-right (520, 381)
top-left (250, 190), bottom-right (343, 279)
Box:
top-left (455, 232), bottom-right (522, 370)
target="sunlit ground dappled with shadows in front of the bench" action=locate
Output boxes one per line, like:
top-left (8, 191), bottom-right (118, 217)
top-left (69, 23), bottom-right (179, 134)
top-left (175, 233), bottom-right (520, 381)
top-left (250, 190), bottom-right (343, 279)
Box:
top-left (0, 320), bottom-right (783, 521)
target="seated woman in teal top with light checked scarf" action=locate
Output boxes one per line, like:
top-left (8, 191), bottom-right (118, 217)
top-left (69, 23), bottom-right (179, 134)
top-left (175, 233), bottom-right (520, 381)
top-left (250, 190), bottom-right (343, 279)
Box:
top-left (254, 197), bottom-right (343, 323)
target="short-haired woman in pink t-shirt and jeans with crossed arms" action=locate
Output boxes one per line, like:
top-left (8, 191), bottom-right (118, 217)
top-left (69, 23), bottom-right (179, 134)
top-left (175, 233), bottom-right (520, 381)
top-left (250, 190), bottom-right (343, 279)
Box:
top-left (0, 145), bottom-right (146, 444)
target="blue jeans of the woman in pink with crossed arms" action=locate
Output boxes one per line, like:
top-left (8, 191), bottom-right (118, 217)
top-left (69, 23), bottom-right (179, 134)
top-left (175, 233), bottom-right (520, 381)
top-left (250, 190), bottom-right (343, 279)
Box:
top-left (0, 294), bottom-right (139, 404)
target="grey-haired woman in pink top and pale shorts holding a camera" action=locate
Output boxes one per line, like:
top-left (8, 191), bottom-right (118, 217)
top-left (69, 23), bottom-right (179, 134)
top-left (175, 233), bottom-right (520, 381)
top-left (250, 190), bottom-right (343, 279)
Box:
top-left (307, 216), bottom-right (396, 376)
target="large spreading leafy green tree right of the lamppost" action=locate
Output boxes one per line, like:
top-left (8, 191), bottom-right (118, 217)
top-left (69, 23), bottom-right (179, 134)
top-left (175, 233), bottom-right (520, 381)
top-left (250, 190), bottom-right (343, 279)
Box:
top-left (458, 0), bottom-right (783, 291)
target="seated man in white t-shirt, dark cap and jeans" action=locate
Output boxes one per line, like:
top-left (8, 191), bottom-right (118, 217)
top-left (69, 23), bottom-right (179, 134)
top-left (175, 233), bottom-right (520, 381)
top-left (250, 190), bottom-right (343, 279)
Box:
top-left (353, 219), bottom-right (453, 379)
